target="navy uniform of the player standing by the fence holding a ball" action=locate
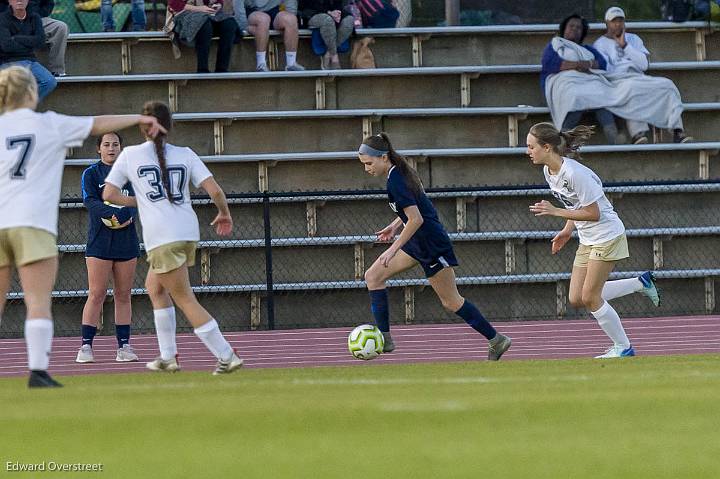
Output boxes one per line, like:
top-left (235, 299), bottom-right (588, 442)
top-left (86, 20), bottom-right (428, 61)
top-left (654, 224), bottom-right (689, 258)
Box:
top-left (82, 161), bottom-right (140, 260)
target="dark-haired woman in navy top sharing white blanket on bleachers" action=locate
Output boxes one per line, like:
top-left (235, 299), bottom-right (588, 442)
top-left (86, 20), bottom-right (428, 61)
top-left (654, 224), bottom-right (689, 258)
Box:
top-left (540, 14), bottom-right (618, 145)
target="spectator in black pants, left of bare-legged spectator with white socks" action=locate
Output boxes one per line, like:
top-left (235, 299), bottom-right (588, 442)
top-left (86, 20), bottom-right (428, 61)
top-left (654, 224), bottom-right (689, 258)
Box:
top-left (163, 0), bottom-right (238, 73)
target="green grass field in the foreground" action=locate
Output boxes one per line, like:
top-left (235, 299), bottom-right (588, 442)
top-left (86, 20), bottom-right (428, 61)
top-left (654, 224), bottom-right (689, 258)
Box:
top-left (0, 355), bottom-right (720, 479)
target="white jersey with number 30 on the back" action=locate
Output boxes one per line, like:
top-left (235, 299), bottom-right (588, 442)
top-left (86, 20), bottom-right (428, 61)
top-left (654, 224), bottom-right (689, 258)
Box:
top-left (105, 141), bottom-right (212, 251)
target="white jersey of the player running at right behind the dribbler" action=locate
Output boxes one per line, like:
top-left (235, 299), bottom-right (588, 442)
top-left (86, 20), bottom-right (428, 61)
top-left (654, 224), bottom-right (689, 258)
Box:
top-left (543, 157), bottom-right (625, 245)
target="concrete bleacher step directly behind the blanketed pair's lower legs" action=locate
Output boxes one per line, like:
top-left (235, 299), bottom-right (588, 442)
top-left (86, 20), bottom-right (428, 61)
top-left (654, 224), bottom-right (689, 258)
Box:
top-left (62, 103), bottom-right (720, 159)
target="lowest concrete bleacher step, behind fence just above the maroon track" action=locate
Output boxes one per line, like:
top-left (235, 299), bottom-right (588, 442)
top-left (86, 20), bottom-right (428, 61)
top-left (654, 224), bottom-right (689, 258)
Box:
top-left (0, 272), bottom-right (720, 336)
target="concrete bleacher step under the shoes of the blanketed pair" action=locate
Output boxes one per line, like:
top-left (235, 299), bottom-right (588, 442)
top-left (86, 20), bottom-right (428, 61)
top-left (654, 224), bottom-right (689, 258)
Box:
top-left (62, 144), bottom-right (720, 198)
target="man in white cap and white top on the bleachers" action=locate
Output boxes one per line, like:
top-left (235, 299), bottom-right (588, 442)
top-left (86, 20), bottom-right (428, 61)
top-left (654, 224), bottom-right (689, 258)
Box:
top-left (593, 7), bottom-right (691, 144)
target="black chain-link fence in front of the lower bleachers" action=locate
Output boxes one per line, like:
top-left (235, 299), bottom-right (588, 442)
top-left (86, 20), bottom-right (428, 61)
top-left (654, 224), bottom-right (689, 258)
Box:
top-left (0, 181), bottom-right (720, 337)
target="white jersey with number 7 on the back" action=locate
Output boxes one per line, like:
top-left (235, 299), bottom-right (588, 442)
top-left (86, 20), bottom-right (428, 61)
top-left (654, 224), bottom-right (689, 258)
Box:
top-left (0, 108), bottom-right (93, 236)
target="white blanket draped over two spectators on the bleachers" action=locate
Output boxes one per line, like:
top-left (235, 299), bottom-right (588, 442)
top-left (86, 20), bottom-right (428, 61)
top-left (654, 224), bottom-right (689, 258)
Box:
top-left (545, 37), bottom-right (683, 129)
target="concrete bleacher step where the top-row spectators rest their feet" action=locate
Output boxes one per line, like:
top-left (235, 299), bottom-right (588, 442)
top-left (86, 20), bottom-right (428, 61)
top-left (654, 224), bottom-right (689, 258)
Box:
top-left (44, 61), bottom-right (720, 115)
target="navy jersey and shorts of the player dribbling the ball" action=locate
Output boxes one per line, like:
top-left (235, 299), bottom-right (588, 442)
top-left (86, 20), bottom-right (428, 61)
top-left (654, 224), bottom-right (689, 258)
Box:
top-left (387, 166), bottom-right (457, 277)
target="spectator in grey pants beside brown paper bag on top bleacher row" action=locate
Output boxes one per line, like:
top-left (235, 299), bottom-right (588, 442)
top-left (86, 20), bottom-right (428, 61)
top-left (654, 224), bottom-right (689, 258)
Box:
top-left (300, 0), bottom-right (355, 70)
